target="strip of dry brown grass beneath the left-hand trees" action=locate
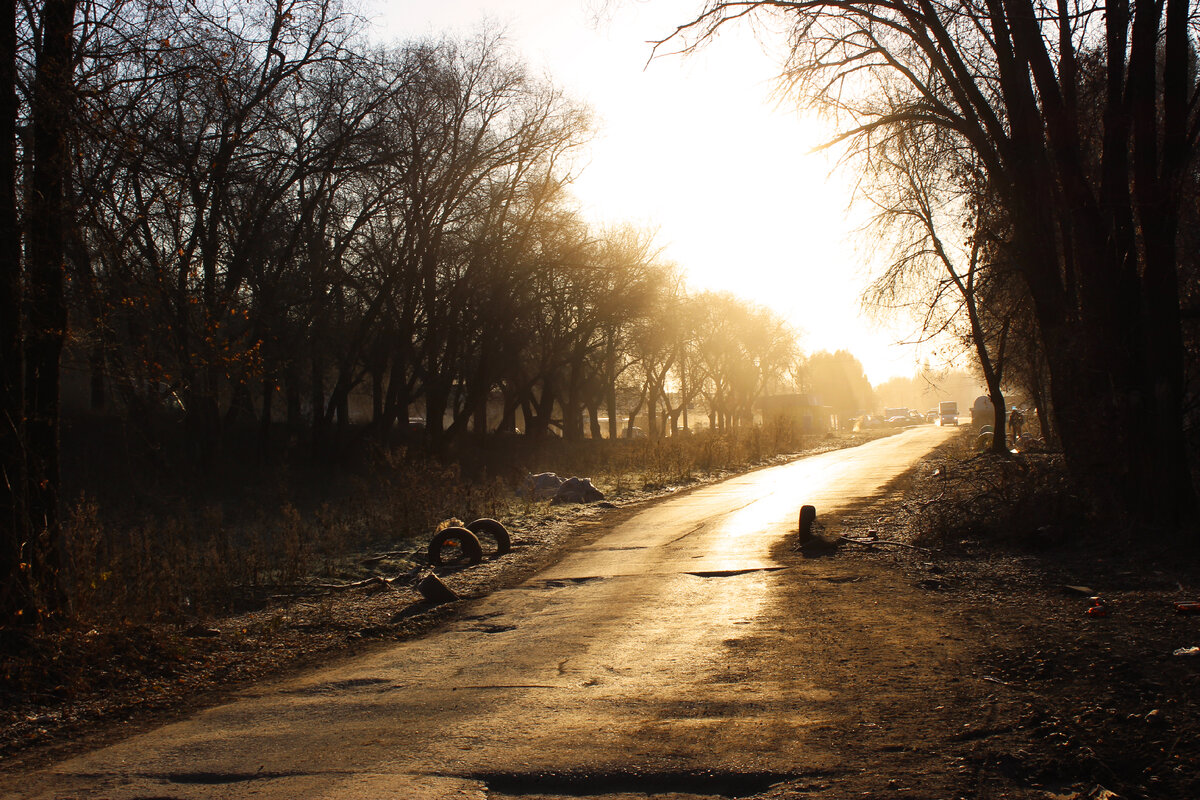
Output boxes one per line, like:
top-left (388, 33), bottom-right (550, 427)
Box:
top-left (54, 426), bottom-right (846, 625)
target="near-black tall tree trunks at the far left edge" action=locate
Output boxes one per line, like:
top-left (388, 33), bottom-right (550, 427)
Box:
top-left (0, 0), bottom-right (76, 631)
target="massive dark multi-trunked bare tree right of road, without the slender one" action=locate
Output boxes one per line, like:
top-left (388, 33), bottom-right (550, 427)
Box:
top-left (672, 0), bottom-right (1200, 528)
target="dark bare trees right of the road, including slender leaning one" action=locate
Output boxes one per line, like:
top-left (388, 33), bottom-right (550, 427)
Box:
top-left (662, 0), bottom-right (1200, 531)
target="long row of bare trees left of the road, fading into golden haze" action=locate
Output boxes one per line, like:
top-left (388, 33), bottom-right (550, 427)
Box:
top-left (0, 0), bottom-right (798, 630)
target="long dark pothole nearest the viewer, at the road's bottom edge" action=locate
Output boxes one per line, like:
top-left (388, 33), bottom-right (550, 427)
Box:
top-left (468, 770), bottom-right (814, 800)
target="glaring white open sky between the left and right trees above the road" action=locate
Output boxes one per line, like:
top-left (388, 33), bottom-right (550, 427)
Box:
top-left (366, 0), bottom-right (918, 383)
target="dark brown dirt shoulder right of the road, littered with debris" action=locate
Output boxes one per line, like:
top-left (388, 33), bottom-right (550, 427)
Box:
top-left (761, 445), bottom-right (1200, 800)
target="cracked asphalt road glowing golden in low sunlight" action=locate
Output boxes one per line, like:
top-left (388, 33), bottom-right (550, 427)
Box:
top-left (11, 426), bottom-right (950, 800)
